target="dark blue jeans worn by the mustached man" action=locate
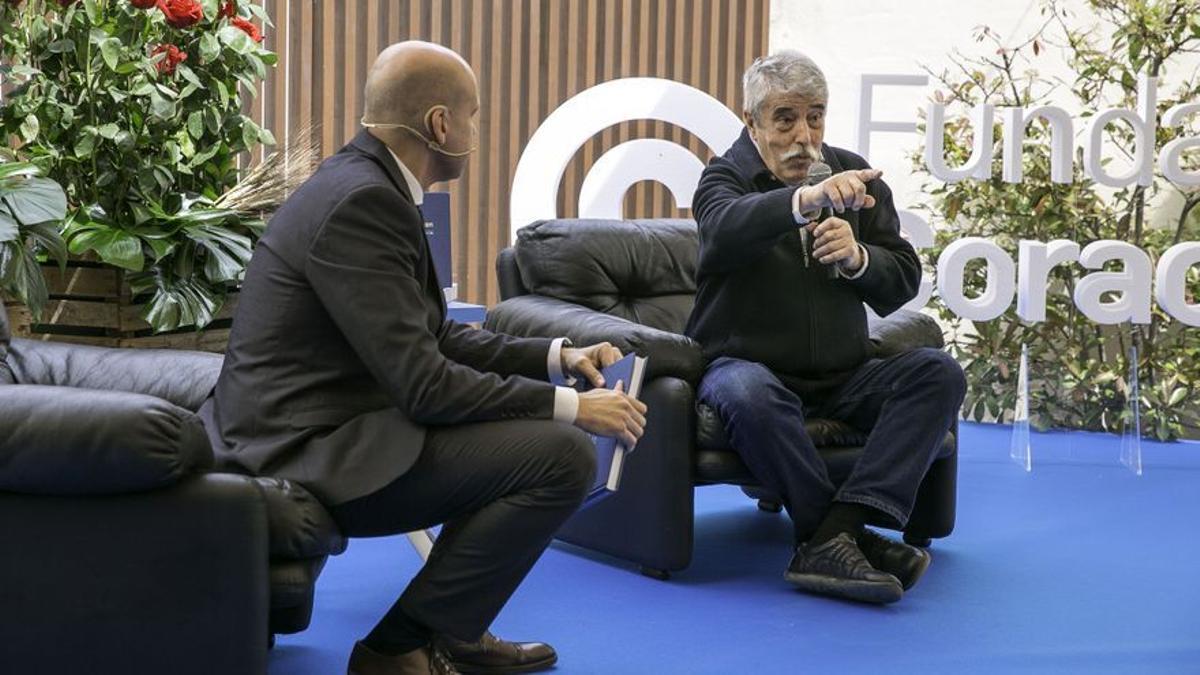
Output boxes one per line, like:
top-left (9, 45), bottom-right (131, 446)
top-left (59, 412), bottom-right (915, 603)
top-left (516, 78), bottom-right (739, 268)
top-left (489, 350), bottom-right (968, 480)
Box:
top-left (698, 348), bottom-right (966, 543)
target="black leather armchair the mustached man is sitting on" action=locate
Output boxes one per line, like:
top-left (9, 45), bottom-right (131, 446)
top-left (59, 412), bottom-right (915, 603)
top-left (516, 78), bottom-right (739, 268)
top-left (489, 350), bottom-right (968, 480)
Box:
top-left (486, 220), bottom-right (958, 579)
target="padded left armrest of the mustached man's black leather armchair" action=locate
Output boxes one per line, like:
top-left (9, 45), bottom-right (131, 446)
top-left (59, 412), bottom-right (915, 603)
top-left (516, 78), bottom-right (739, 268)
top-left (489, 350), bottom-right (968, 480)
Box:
top-left (485, 295), bottom-right (704, 386)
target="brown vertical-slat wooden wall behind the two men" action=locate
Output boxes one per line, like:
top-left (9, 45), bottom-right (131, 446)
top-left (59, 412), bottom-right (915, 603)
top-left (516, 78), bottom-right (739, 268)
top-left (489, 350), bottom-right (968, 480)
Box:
top-left (252, 0), bottom-right (770, 305)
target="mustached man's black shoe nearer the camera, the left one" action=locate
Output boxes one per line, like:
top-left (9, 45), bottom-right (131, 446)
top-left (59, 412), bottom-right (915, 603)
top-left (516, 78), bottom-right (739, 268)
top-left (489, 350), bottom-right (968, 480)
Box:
top-left (784, 532), bottom-right (904, 604)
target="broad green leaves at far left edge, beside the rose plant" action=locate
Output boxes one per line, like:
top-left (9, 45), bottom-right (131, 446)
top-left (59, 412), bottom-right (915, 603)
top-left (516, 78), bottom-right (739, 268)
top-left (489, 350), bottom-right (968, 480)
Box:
top-left (0, 154), bottom-right (67, 316)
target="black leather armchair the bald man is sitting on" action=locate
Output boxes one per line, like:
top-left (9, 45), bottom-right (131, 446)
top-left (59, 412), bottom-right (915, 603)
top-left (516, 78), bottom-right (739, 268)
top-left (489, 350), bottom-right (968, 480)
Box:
top-left (0, 309), bottom-right (346, 675)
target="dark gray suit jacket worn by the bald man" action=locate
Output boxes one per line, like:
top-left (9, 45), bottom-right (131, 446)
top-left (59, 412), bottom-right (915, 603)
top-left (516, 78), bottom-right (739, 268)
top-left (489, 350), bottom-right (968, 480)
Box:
top-left (203, 132), bottom-right (554, 504)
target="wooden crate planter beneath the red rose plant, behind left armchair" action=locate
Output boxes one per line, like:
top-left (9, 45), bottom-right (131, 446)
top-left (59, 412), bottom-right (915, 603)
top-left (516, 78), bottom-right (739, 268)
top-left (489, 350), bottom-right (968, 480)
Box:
top-left (5, 261), bottom-right (238, 353)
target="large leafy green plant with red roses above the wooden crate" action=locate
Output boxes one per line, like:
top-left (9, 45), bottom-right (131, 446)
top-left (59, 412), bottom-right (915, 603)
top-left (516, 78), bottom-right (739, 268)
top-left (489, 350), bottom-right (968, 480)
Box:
top-left (0, 0), bottom-right (276, 330)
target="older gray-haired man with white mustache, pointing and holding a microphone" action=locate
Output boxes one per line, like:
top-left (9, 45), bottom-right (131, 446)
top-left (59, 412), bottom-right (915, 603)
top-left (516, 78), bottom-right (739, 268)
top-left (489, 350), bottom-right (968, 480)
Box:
top-left (686, 50), bottom-right (966, 603)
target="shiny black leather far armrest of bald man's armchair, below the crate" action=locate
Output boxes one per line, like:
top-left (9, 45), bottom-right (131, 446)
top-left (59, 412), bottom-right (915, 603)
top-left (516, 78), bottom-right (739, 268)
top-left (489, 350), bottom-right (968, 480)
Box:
top-left (8, 338), bottom-right (223, 412)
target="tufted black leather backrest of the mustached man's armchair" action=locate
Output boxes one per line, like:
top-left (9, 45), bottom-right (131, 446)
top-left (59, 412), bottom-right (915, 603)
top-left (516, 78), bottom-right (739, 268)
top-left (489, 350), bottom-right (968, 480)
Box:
top-left (508, 219), bottom-right (700, 333)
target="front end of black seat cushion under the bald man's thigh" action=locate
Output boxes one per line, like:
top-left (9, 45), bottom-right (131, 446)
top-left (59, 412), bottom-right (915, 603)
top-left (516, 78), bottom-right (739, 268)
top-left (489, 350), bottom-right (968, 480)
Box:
top-left (254, 476), bottom-right (346, 561)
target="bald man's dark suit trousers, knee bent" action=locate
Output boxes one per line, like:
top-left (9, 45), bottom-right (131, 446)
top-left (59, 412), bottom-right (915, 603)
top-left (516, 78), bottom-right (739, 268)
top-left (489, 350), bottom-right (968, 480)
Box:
top-left (330, 420), bottom-right (595, 641)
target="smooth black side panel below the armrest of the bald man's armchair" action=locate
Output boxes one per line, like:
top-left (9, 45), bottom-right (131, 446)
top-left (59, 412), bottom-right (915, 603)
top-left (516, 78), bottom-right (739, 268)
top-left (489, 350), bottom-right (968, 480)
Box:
top-left (0, 473), bottom-right (270, 675)
